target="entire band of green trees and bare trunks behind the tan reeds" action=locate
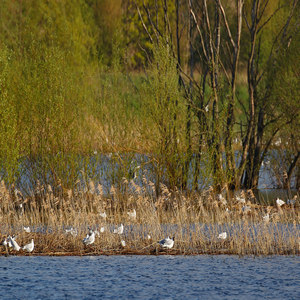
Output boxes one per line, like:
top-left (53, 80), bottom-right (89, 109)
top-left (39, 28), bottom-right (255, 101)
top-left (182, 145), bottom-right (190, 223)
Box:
top-left (0, 0), bottom-right (300, 190)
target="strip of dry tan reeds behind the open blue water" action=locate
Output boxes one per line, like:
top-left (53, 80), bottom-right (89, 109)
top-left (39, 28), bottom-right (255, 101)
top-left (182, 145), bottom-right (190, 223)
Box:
top-left (0, 177), bottom-right (300, 256)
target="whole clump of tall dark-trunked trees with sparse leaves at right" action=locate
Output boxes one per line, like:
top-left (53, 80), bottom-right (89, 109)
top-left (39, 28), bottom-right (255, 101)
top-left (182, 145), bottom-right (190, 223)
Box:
top-left (189, 0), bottom-right (297, 189)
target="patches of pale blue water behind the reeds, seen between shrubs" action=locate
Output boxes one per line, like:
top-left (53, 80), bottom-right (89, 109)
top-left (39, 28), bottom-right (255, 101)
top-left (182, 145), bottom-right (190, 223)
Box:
top-left (16, 153), bottom-right (296, 203)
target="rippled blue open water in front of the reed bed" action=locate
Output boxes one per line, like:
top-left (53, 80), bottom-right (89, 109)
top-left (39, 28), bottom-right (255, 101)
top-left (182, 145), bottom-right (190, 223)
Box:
top-left (0, 255), bottom-right (300, 299)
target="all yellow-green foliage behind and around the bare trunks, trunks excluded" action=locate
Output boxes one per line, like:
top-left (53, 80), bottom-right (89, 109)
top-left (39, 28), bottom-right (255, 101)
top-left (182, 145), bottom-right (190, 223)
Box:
top-left (0, 0), bottom-right (300, 192)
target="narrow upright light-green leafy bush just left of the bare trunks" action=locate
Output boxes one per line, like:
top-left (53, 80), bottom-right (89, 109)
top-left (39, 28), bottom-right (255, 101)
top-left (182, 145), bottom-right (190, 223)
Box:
top-left (144, 43), bottom-right (187, 187)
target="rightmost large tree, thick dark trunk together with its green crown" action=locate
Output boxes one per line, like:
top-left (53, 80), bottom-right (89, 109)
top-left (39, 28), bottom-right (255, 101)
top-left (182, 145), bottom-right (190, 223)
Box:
top-left (238, 0), bottom-right (299, 188)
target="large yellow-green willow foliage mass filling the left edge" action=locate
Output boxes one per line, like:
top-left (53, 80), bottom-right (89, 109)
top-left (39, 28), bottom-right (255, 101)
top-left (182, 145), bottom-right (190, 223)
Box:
top-left (0, 0), bottom-right (94, 186)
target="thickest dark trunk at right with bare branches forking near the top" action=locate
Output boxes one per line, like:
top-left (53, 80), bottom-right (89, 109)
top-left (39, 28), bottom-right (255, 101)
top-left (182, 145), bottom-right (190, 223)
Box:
top-left (238, 0), bottom-right (297, 188)
